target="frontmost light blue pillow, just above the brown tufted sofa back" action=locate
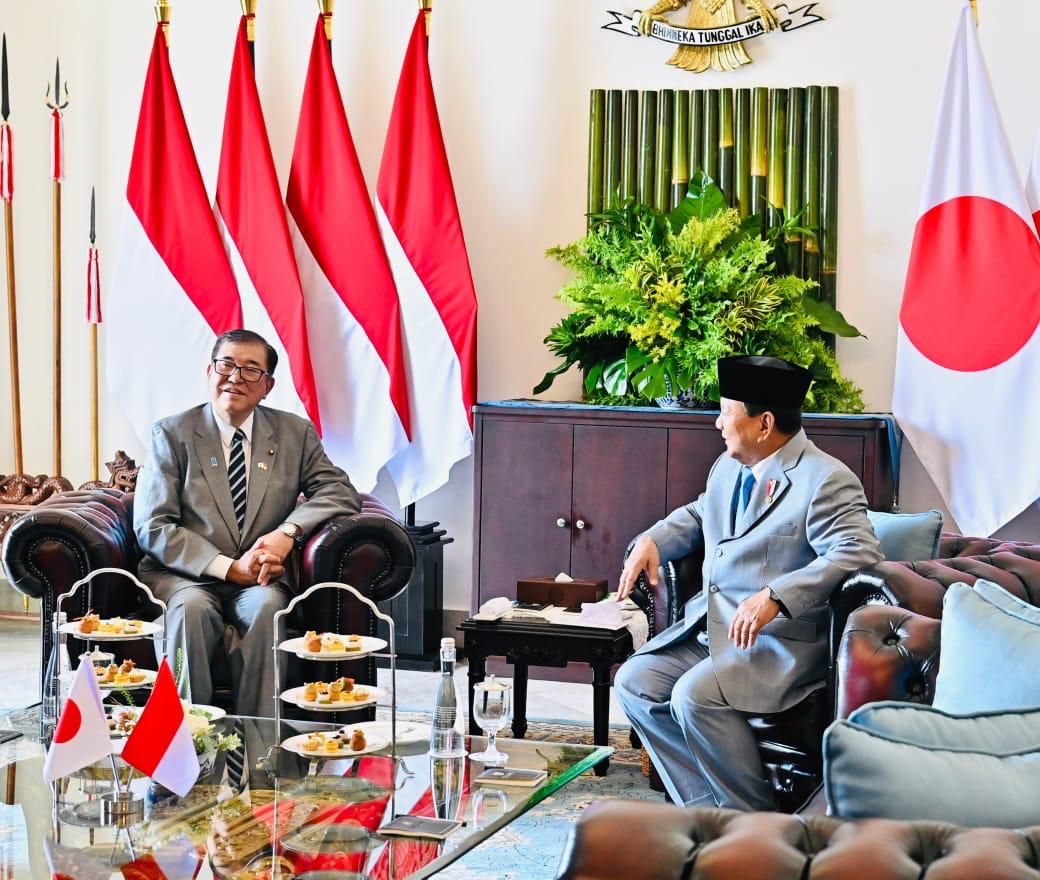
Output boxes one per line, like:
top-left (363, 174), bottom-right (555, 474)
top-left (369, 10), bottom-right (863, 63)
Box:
top-left (824, 721), bottom-right (1040, 828)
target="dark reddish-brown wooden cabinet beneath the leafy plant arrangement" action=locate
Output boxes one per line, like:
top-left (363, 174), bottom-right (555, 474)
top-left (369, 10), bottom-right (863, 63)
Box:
top-left (471, 400), bottom-right (893, 610)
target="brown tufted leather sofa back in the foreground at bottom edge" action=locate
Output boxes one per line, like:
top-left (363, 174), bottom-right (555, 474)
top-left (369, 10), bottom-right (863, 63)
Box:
top-left (558, 801), bottom-right (1040, 880)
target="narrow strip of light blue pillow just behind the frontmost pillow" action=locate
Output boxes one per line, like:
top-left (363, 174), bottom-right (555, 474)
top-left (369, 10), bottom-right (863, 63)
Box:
top-left (849, 700), bottom-right (1040, 754)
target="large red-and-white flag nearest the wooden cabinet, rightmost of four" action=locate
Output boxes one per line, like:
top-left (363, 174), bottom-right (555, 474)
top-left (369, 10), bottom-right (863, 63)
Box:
top-left (376, 10), bottom-right (476, 504)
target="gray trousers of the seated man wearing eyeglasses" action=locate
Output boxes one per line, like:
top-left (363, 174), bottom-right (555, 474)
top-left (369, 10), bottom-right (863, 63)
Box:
top-left (166, 583), bottom-right (291, 718)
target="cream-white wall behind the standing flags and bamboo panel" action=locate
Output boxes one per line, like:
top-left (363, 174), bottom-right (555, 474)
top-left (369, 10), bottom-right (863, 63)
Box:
top-left (0, 0), bottom-right (1040, 609)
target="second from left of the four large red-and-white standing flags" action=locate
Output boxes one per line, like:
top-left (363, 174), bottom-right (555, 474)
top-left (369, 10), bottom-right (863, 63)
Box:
top-left (216, 16), bottom-right (321, 433)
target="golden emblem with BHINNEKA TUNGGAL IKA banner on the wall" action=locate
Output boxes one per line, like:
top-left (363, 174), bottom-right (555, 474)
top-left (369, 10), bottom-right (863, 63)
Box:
top-left (603, 0), bottom-right (823, 73)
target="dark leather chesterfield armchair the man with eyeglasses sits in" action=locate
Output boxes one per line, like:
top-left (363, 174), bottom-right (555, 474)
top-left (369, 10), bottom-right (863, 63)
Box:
top-left (0, 489), bottom-right (415, 705)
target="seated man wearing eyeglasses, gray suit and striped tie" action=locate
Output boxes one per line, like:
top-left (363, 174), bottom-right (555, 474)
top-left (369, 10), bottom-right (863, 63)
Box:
top-left (134, 330), bottom-right (361, 716)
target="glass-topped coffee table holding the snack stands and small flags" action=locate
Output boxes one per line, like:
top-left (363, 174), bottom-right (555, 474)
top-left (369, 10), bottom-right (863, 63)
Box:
top-left (0, 709), bottom-right (612, 880)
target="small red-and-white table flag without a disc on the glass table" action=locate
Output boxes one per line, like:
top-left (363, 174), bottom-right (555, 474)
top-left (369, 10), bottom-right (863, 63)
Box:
top-left (119, 658), bottom-right (200, 798)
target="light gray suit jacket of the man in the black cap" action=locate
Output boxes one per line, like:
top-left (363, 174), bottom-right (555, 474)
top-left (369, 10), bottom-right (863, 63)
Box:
top-left (640, 431), bottom-right (882, 713)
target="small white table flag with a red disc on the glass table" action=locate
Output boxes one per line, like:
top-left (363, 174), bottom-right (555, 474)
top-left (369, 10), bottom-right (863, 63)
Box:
top-left (44, 661), bottom-right (112, 782)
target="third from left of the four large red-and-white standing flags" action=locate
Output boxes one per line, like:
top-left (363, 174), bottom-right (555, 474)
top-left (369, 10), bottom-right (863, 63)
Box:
top-left (286, 16), bottom-right (410, 492)
